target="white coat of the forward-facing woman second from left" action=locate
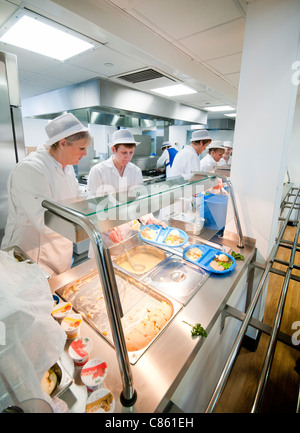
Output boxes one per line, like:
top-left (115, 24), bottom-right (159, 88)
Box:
top-left (87, 156), bottom-right (143, 196)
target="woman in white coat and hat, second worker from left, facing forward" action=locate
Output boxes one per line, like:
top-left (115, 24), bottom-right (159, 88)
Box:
top-left (87, 129), bottom-right (165, 245)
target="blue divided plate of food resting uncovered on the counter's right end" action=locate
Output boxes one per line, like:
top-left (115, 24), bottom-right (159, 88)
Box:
top-left (183, 244), bottom-right (236, 274)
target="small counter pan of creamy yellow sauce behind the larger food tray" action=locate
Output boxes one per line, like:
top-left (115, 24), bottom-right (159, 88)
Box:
top-left (115, 245), bottom-right (166, 275)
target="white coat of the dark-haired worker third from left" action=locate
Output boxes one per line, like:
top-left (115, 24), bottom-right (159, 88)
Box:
top-left (169, 146), bottom-right (200, 177)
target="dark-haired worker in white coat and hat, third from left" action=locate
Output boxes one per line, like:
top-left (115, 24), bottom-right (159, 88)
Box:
top-left (170, 129), bottom-right (211, 179)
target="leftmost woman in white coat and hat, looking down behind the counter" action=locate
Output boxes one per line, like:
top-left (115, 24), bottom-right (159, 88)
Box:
top-left (1, 113), bottom-right (91, 276)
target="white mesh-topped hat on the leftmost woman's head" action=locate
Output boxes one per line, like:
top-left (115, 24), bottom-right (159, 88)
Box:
top-left (45, 113), bottom-right (88, 147)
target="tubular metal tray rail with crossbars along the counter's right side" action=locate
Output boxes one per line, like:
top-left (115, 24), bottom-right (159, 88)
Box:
top-left (206, 188), bottom-right (300, 413)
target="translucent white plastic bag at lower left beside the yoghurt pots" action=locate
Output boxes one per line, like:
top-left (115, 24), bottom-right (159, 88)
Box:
top-left (0, 251), bottom-right (66, 412)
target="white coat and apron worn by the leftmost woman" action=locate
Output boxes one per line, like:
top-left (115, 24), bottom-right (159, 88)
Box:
top-left (1, 148), bottom-right (80, 276)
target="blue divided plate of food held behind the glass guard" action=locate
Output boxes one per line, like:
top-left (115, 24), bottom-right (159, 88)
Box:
top-left (139, 224), bottom-right (189, 247)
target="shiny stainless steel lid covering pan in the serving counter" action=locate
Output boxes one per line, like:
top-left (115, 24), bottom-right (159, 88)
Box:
top-left (147, 257), bottom-right (208, 305)
